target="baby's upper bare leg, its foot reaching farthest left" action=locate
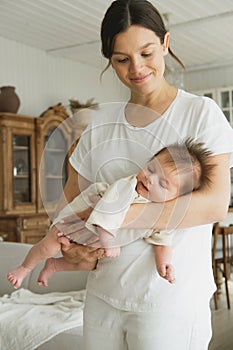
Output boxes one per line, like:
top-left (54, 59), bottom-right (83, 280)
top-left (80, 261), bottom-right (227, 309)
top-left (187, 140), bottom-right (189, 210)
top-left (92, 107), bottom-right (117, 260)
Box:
top-left (7, 227), bottom-right (60, 288)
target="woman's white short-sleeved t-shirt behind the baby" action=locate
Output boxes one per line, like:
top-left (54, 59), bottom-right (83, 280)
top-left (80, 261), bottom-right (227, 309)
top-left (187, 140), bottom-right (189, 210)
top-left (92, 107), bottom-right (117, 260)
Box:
top-left (70, 90), bottom-right (233, 312)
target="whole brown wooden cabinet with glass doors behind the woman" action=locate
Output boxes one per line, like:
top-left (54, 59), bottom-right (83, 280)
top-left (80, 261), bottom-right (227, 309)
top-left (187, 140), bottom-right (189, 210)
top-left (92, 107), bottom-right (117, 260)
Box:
top-left (0, 112), bottom-right (82, 243)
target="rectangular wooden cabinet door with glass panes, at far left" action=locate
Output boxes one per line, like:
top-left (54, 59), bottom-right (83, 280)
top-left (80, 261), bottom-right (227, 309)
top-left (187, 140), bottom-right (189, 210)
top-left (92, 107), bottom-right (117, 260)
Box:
top-left (0, 113), bottom-right (36, 215)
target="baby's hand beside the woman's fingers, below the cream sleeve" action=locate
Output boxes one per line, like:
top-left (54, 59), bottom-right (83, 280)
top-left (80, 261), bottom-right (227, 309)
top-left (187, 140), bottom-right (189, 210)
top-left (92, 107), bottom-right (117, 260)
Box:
top-left (98, 227), bottom-right (120, 258)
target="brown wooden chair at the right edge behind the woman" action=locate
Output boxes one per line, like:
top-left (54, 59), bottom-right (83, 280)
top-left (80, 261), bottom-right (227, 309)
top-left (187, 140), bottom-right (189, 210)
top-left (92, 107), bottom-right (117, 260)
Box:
top-left (212, 223), bottom-right (233, 309)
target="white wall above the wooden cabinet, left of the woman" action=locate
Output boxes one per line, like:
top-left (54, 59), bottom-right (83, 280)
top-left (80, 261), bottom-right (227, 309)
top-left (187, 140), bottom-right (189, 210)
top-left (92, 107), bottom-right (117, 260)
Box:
top-left (0, 37), bottom-right (128, 116)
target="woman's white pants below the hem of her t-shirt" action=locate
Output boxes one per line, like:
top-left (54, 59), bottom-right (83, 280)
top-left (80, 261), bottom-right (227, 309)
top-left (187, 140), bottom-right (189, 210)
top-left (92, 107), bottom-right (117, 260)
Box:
top-left (84, 294), bottom-right (211, 350)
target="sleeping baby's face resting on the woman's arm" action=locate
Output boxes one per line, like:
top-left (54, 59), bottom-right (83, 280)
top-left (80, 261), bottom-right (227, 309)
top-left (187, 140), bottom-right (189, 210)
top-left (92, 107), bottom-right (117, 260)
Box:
top-left (136, 154), bottom-right (179, 202)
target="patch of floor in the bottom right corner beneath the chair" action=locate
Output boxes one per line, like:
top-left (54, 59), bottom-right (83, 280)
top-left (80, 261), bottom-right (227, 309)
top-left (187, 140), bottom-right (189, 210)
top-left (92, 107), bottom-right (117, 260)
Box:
top-left (209, 281), bottom-right (233, 350)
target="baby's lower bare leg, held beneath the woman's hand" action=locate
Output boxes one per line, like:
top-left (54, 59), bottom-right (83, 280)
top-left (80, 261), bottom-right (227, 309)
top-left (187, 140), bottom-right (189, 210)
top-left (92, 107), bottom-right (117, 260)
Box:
top-left (38, 258), bottom-right (96, 287)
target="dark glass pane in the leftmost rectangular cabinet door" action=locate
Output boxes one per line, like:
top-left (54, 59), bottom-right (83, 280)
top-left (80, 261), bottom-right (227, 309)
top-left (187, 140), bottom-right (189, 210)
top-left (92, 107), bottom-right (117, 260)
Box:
top-left (13, 135), bottom-right (32, 206)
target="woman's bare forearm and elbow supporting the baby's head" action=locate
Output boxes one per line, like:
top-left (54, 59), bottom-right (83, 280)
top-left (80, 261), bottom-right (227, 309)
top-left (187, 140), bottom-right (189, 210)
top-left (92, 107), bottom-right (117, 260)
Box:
top-left (122, 154), bottom-right (231, 230)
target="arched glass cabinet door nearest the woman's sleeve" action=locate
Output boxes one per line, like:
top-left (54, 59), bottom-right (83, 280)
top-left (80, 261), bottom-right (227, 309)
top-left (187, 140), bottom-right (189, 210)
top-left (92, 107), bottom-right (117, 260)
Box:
top-left (38, 118), bottom-right (72, 219)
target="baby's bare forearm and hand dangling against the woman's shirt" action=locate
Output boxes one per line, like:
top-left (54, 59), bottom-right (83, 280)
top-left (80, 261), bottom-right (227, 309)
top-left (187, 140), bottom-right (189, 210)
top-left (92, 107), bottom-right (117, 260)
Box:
top-left (154, 244), bottom-right (175, 283)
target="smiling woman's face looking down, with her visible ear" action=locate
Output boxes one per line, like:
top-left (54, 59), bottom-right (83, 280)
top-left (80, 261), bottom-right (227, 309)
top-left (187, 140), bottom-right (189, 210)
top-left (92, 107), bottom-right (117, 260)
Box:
top-left (111, 25), bottom-right (169, 95)
